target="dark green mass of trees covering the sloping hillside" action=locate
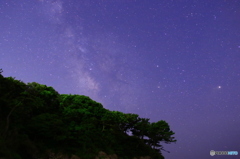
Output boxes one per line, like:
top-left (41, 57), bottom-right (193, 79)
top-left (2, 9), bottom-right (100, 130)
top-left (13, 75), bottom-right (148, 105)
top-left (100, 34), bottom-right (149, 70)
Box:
top-left (0, 69), bottom-right (176, 159)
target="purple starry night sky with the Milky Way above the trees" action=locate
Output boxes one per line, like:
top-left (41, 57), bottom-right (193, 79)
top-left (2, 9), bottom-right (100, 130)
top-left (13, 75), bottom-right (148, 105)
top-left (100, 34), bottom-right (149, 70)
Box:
top-left (0, 0), bottom-right (240, 159)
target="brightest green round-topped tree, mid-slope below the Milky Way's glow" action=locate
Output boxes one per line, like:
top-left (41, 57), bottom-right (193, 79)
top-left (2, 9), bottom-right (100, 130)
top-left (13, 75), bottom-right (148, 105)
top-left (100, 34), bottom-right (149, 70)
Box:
top-left (60, 94), bottom-right (105, 150)
